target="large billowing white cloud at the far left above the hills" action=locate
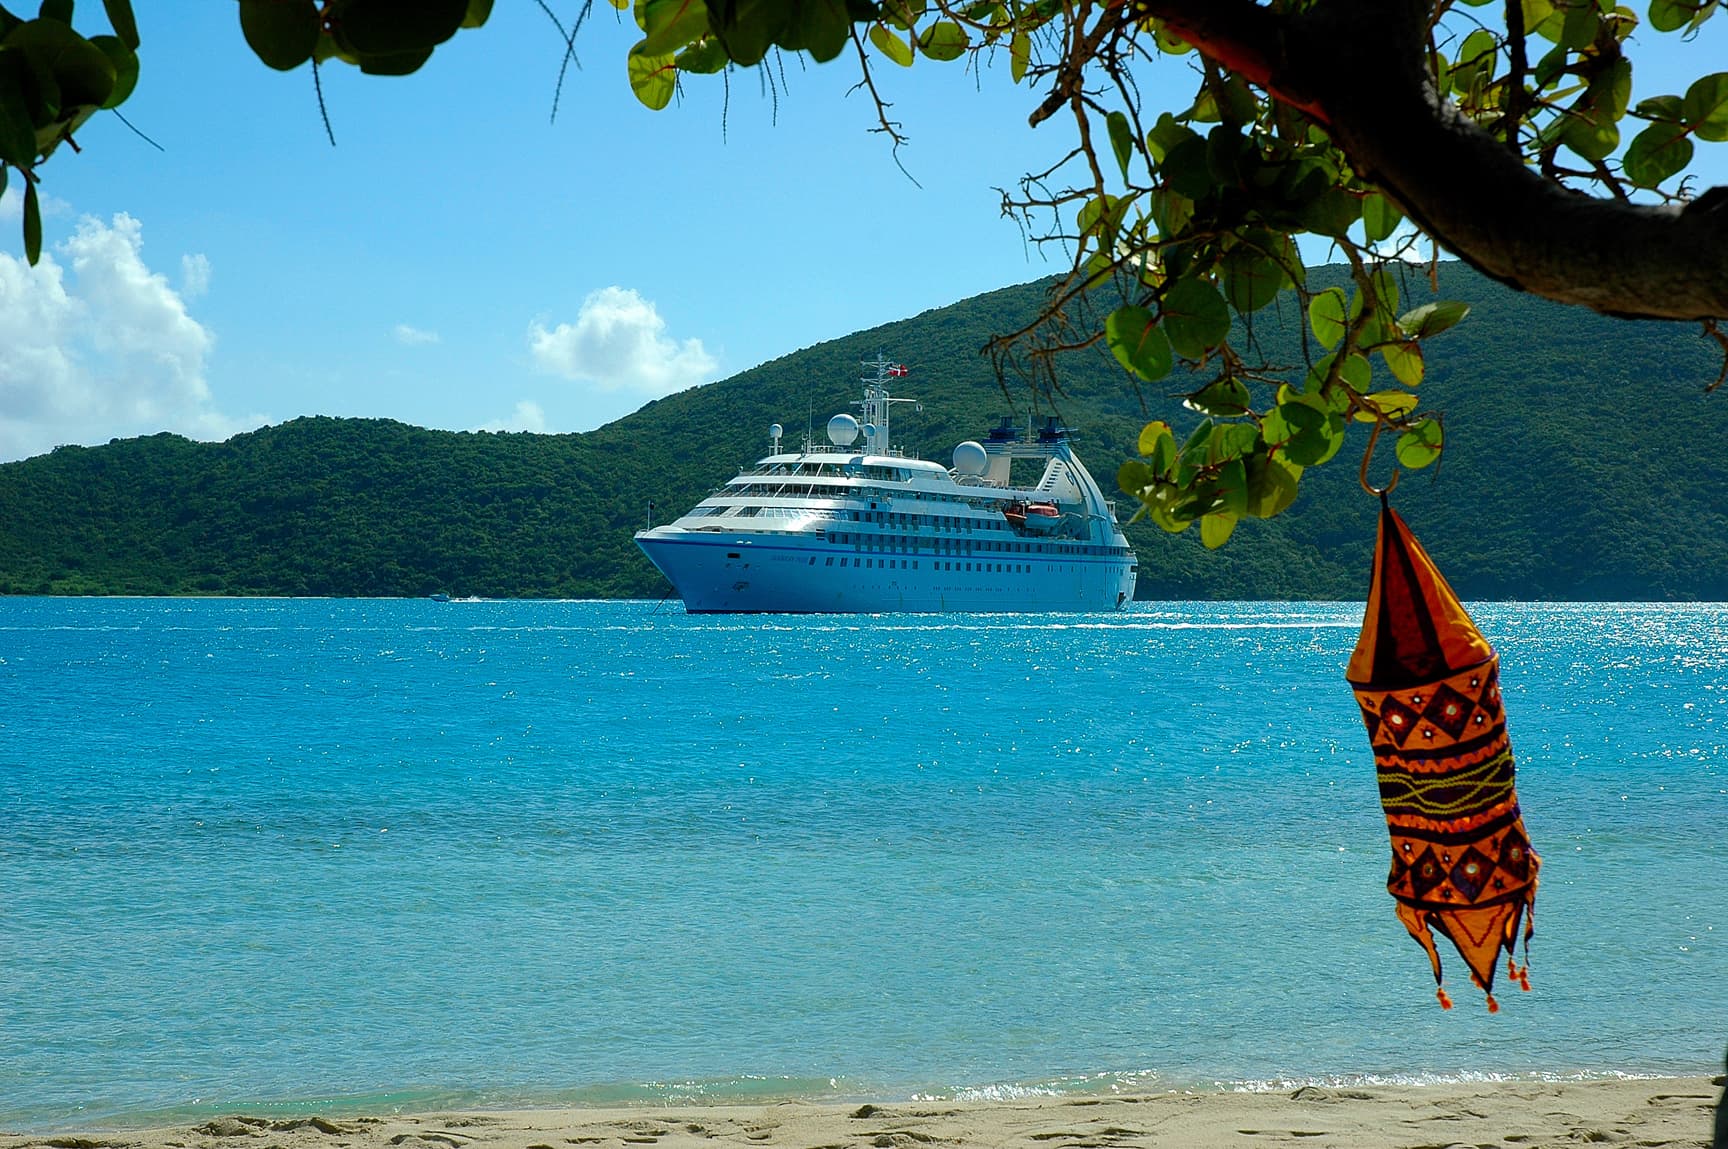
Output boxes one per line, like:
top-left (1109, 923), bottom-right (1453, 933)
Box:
top-left (0, 214), bottom-right (263, 458)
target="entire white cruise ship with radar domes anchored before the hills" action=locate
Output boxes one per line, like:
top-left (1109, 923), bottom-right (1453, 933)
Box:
top-left (636, 356), bottom-right (1139, 613)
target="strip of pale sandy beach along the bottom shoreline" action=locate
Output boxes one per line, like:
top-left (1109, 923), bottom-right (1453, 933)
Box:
top-left (10, 1076), bottom-right (1721, 1149)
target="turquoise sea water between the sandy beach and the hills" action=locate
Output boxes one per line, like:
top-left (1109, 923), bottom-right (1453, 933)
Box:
top-left (0, 598), bottom-right (1728, 1130)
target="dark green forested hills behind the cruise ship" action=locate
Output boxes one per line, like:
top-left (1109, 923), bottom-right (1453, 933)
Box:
top-left (0, 264), bottom-right (1728, 600)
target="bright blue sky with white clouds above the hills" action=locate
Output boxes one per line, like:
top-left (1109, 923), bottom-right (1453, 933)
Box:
top-left (0, 0), bottom-right (1728, 460)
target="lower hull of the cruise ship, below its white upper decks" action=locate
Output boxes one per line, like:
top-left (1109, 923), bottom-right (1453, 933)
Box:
top-left (636, 527), bottom-right (1135, 613)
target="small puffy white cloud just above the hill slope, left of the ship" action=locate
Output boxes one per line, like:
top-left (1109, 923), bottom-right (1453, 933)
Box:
top-left (529, 287), bottom-right (719, 397)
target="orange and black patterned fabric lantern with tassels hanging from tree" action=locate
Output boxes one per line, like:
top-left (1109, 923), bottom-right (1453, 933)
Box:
top-left (1344, 494), bottom-right (1541, 1011)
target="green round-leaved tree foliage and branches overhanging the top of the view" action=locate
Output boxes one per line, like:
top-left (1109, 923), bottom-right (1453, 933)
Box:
top-left (0, 0), bottom-right (1728, 546)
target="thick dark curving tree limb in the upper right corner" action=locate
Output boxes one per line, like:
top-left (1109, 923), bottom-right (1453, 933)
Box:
top-left (1140, 0), bottom-right (1728, 320)
